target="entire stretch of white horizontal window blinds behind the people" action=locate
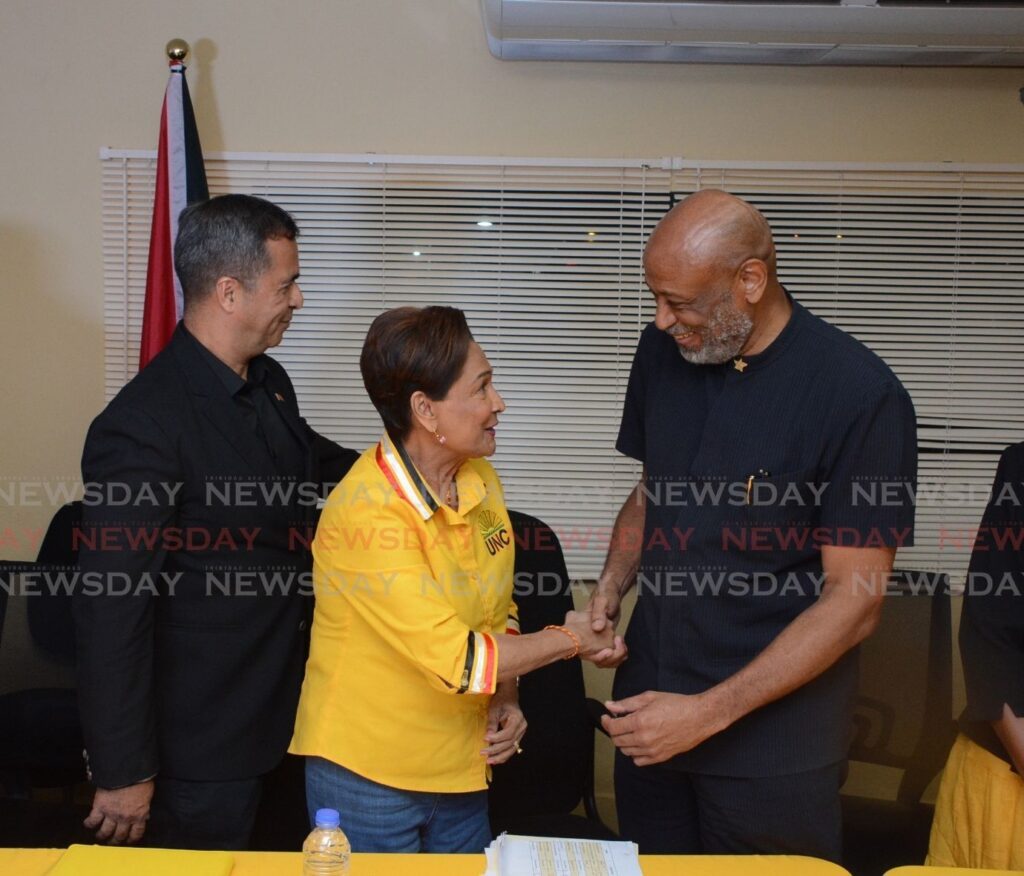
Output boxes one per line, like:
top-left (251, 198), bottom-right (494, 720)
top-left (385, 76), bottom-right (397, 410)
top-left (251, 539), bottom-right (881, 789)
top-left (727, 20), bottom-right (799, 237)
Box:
top-left (102, 151), bottom-right (1024, 579)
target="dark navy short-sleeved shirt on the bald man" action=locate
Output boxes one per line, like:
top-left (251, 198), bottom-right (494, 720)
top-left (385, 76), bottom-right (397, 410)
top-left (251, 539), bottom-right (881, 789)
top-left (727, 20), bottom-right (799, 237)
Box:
top-left (615, 301), bottom-right (916, 777)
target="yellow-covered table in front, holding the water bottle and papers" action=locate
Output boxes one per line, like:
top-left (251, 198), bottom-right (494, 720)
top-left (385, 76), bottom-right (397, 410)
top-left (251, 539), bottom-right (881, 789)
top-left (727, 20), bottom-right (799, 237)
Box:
top-left (0, 848), bottom-right (847, 876)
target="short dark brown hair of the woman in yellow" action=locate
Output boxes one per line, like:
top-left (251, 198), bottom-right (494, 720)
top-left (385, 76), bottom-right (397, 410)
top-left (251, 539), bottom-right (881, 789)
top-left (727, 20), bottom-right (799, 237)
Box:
top-left (359, 306), bottom-right (473, 441)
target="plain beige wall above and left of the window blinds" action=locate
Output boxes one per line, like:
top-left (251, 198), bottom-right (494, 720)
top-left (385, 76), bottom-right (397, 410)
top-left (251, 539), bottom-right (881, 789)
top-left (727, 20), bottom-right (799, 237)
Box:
top-left (0, 0), bottom-right (1024, 558)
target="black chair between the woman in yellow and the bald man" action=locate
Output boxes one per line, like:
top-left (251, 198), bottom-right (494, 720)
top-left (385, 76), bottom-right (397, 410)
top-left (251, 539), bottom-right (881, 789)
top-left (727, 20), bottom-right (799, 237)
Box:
top-left (488, 511), bottom-right (616, 839)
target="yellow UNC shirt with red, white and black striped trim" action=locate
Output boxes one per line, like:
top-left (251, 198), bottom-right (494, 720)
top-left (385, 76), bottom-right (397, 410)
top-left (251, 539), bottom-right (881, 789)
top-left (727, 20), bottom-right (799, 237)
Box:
top-left (289, 436), bottom-right (519, 792)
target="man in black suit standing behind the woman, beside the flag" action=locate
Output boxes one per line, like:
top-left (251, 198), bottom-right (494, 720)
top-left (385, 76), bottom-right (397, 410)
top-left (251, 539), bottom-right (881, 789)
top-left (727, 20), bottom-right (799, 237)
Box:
top-left (74, 195), bottom-right (356, 848)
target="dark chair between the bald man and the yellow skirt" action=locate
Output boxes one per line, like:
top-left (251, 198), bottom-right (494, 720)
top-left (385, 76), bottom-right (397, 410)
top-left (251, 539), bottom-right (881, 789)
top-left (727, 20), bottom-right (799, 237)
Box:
top-left (841, 570), bottom-right (955, 876)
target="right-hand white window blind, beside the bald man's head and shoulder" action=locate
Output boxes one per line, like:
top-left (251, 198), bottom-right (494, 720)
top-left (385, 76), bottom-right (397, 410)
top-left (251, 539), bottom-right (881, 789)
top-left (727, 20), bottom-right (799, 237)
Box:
top-left (674, 165), bottom-right (1024, 581)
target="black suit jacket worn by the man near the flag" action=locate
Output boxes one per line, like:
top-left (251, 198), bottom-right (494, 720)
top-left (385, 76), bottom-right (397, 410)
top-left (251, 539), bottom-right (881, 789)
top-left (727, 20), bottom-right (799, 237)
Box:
top-left (73, 326), bottom-right (357, 788)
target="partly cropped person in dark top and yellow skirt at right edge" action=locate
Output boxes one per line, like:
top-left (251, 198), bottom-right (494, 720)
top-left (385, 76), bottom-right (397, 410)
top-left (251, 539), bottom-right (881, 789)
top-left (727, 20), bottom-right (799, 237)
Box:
top-left (925, 443), bottom-right (1024, 870)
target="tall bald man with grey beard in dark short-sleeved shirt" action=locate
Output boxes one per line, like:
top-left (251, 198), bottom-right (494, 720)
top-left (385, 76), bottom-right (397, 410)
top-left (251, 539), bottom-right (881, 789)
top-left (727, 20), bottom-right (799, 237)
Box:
top-left (591, 191), bottom-right (916, 861)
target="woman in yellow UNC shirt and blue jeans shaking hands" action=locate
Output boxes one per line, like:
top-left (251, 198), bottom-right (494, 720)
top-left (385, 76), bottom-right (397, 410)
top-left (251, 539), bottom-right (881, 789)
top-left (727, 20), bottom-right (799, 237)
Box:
top-left (290, 307), bottom-right (613, 852)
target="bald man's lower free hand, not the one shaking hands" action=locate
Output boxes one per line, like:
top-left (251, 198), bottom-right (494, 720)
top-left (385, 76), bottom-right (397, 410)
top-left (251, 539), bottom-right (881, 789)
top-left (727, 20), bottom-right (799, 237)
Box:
top-left (601, 691), bottom-right (726, 766)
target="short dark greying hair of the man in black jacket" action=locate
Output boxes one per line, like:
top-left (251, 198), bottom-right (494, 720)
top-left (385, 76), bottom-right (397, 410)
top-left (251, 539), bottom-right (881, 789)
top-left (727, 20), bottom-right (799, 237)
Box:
top-left (174, 195), bottom-right (299, 309)
